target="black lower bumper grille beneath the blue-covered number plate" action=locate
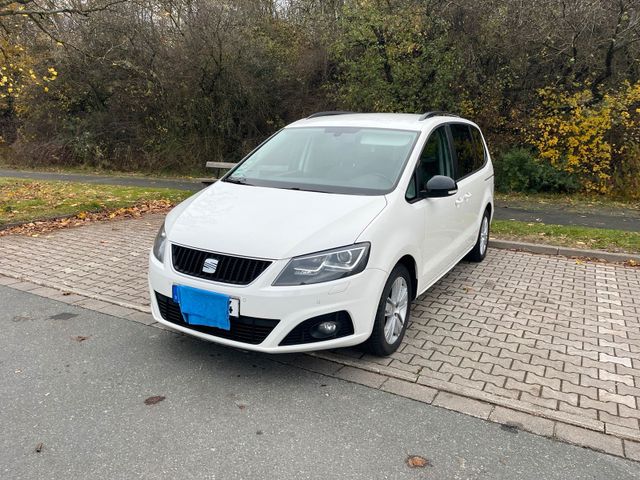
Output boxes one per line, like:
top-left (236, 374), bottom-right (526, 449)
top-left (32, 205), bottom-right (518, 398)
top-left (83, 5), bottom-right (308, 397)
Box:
top-left (156, 292), bottom-right (278, 345)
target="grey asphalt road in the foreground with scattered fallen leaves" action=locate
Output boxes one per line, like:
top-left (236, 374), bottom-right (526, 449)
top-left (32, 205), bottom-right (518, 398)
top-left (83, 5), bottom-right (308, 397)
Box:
top-left (0, 287), bottom-right (640, 480)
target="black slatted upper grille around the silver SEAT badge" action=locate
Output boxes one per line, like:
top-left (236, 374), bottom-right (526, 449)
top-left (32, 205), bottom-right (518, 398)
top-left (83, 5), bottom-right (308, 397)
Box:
top-left (171, 245), bottom-right (271, 285)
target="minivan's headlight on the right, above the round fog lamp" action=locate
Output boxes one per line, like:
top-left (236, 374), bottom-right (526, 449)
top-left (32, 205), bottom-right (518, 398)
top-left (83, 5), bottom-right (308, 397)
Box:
top-left (273, 243), bottom-right (370, 286)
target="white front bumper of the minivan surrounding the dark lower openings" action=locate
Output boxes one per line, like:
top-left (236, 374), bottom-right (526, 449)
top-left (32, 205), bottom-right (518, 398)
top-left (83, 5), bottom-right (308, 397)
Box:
top-left (149, 254), bottom-right (388, 353)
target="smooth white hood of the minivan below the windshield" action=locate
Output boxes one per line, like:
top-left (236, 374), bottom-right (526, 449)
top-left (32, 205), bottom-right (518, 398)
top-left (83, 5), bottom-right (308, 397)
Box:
top-left (166, 182), bottom-right (387, 260)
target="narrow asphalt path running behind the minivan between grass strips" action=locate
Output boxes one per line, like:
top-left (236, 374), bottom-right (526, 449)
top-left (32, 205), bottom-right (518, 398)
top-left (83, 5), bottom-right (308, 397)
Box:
top-left (0, 169), bottom-right (640, 232)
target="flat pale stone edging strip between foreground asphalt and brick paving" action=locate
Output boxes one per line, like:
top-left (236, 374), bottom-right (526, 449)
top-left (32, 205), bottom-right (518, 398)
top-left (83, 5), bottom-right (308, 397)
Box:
top-left (0, 270), bottom-right (640, 462)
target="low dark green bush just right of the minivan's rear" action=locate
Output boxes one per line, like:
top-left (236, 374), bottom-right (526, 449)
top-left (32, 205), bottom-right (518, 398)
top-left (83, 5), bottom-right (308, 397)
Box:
top-left (493, 148), bottom-right (580, 193)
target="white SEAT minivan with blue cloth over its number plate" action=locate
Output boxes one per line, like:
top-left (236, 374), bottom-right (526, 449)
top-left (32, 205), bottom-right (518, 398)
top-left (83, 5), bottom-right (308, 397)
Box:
top-left (149, 112), bottom-right (493, 355)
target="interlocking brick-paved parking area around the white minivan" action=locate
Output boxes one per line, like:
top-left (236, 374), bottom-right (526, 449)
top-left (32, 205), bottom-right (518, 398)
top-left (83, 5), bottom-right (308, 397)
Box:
top-left (0, 215), bottom-right (640, 460)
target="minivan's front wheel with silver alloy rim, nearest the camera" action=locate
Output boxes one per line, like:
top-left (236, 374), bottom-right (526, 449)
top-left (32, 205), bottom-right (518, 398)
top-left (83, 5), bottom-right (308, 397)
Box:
top-left (363, 264), bottom-right (413, 357)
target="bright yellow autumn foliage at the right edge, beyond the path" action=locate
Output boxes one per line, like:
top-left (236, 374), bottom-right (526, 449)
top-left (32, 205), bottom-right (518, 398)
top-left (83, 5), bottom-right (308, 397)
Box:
top-left (527, 82), bottom-right (640, 193)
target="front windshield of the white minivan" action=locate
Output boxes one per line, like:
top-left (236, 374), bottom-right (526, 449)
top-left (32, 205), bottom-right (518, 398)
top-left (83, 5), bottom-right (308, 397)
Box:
top-left (224, 127), bottom-right (419, 195)
